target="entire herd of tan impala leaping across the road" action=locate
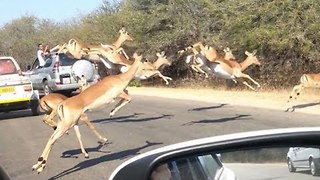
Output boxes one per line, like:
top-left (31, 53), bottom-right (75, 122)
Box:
top-left (32, 28), bottom-right (320, 173)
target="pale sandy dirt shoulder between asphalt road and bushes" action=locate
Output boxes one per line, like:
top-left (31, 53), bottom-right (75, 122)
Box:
top-left (128, 87), bottom-right (320, 114)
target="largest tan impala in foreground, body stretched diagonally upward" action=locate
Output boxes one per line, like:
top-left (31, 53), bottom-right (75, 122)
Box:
top-left (32, 50), bottom-right (142, 173)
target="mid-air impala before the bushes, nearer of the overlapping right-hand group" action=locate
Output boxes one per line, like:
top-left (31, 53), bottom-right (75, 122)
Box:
top-left (189, 46), bottom-right (261, 91)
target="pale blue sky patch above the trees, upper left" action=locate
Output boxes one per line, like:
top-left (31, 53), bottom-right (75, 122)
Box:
top-left (0, 0), bottom-right (103, 27)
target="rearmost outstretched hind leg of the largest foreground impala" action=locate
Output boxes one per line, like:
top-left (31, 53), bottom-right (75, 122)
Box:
top-left (32, 123), bottom-right (68, 174)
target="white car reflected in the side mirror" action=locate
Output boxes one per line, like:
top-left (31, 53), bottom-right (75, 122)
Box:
top-left (287, 147), bottom-right (320, 176)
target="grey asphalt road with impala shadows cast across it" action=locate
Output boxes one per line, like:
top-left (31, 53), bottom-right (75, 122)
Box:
top-left (0, 96), bottom-right (320, 180)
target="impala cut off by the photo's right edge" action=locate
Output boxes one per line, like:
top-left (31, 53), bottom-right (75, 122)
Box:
top-left (286, 73), bottom-right (320, 111)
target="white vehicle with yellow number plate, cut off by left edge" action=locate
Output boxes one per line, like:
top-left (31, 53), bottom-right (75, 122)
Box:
top-left (0, 57), bottom-right (40, 116)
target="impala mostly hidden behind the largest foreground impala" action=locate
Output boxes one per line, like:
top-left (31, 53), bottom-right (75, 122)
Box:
top-left (39, 77), bottom-right (108, 145)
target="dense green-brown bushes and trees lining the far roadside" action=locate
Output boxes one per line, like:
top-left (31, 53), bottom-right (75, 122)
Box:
top-left (0, 0), bottom-right (320, 89)
